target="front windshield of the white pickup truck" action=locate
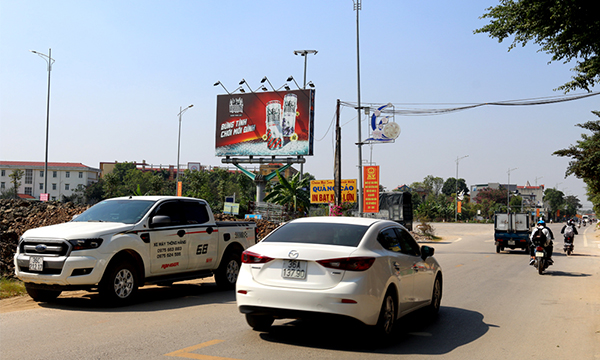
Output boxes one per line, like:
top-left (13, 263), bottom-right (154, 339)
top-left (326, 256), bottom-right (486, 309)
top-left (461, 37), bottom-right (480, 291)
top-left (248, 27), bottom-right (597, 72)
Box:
top-left (73, 200), bottom-right (155, 224)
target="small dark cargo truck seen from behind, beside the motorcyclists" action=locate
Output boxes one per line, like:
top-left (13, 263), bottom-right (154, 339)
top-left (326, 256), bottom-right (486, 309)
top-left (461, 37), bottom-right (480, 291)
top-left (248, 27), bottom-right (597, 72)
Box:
top-left (494, 213), bottom-right (532, 253)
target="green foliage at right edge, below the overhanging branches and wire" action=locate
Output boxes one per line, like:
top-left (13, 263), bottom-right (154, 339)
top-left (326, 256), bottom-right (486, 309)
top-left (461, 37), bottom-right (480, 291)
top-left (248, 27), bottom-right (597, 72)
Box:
top-left (553, 111), bottom-right (600, 214)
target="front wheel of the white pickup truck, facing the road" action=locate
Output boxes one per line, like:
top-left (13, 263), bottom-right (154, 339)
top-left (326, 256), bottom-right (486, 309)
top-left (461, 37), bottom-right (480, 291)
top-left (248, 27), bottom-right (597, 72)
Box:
top-left (99, 260), bottom-right (138, 305)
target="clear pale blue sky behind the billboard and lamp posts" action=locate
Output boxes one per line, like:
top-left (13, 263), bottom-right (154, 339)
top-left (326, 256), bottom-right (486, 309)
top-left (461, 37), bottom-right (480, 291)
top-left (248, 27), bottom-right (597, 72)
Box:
top-left (0, 0), bottom-right (600, 208)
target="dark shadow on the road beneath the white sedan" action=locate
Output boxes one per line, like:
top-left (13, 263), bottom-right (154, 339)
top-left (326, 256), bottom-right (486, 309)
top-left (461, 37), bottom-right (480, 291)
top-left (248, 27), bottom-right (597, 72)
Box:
top-left (260, 307), bottom-right (497, 355)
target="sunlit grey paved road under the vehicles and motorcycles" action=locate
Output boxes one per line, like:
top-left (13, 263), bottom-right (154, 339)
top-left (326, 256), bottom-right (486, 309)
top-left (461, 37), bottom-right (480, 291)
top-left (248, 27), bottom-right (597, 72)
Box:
top-left (0, 223), bottom-right (600, 360)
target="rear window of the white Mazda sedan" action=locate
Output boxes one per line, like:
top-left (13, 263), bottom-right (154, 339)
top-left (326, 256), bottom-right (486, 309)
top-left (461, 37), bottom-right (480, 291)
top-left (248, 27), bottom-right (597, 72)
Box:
top-left (263, 222), bottom-right (368, 247)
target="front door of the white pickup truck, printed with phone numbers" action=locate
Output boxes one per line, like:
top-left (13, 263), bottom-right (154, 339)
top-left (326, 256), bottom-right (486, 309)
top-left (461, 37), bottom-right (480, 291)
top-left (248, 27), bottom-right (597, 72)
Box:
top-left (149, 200), bottom-right (189, 275)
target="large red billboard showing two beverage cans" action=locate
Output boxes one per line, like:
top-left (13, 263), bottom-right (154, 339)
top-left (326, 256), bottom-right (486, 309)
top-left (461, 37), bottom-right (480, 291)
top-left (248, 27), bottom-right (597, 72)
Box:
top-left (215, 89), bottom-right (315, 156)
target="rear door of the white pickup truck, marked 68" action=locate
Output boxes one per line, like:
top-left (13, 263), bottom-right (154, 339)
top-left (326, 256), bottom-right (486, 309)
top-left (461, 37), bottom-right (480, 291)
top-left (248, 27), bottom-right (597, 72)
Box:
top-left (183, 201), bottom-right (219, 270)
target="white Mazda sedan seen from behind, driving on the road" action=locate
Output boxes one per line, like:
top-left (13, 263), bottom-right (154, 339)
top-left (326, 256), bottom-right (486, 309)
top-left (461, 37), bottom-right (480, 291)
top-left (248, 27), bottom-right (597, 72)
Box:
top-left (236, 217), bottom-right (442, 337)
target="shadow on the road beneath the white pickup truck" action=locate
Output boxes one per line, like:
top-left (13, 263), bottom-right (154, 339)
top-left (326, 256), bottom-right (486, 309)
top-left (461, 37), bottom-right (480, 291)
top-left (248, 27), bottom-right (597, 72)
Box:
top-left (39, 283), bottom-right (235, 312)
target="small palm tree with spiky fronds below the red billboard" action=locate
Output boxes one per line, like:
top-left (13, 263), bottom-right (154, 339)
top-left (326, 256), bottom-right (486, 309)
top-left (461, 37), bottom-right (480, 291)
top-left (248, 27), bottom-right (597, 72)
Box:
top-left (264, 170), bottom-right (310, 212)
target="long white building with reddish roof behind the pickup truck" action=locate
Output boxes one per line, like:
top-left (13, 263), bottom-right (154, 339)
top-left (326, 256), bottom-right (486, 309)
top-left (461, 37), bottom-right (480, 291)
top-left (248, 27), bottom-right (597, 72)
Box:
top-left (0, 161), bottom-right (100, 201)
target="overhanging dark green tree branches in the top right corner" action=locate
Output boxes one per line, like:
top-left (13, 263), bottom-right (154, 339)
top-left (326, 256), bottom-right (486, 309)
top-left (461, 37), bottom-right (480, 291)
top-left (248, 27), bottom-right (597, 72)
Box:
top-left (474, 0), bottom-right (600, 92)
